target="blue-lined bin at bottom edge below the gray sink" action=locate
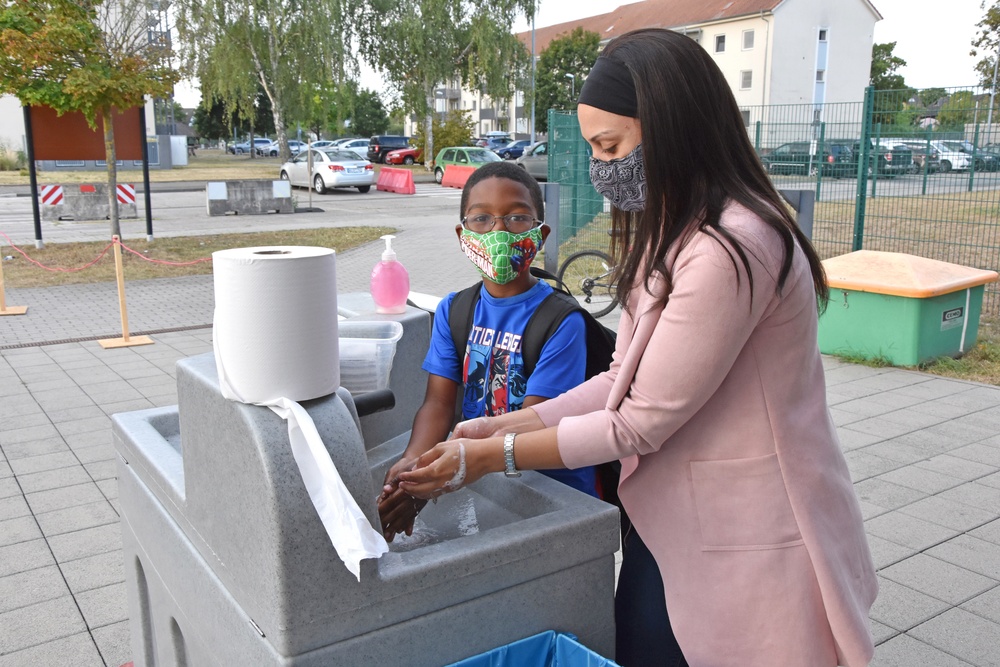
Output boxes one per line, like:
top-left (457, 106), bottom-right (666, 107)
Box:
top-left (448, 630), bottom-right (620, 667)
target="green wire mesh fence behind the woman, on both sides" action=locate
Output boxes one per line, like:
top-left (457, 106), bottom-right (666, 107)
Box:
top-left (549, 88), bottom-right (1000, 316)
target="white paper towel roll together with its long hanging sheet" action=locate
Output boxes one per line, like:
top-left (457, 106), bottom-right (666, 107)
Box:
top-left (212, 246), bottom-right (389, 580)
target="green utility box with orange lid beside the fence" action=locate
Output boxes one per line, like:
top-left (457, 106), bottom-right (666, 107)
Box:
top-left (819, 250), bottom-right (998, 366)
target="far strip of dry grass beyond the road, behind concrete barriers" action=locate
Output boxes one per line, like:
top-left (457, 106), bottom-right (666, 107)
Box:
top-left (0, 148), bottom-right (426, 185)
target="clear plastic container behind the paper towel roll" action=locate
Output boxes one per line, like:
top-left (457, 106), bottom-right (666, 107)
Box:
top-left (337, 320), bottom-right (403, 394)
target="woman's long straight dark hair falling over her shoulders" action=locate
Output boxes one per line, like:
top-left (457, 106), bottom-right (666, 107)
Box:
top-left (602, 29), bottom-right (828, 308)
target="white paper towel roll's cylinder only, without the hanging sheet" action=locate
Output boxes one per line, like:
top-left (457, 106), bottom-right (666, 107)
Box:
top-left (212, 246), bottom-right (340, 403)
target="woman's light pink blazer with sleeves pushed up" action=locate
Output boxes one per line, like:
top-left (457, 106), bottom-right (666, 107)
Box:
top-left (533, 205), bottom-right (878, 667)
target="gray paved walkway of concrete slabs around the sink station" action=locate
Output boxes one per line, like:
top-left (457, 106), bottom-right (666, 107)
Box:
top-left (0, 194), bottom-right (1000, 667)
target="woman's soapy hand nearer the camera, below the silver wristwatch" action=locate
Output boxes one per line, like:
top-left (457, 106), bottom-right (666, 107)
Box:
top-left (399, 439), bottom-right (503, 499)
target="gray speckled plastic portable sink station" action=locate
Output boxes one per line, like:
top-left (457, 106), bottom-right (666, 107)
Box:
top-left (113, 295), bottom-right (619, 667)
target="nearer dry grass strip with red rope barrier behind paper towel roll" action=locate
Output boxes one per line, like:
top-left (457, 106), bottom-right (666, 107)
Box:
top-left (3, 227), bottom-right (396, 287)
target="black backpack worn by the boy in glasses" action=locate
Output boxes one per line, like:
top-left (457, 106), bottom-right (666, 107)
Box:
top-left (448, 266), bottom-right (626, 516)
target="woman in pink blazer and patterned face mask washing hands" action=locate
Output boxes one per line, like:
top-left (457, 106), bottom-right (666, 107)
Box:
top-left (399, 30), bottom-right (877, 667)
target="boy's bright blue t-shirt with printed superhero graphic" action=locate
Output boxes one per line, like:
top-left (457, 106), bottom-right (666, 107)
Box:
top-left (423, 280), bottom-right (597, 496)
